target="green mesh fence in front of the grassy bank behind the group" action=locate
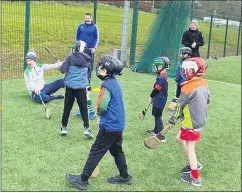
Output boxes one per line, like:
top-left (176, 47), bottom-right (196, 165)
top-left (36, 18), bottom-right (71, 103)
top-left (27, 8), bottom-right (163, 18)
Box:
top-left (1, 1), bottom-right (241, 79)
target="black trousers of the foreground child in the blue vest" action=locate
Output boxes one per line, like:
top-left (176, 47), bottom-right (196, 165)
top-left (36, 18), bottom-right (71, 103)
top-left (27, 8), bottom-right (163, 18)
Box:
top-left (81, 128), bottom-right (128, 181)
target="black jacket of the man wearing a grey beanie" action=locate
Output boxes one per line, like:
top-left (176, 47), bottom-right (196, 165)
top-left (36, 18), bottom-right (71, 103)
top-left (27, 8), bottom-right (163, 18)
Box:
top-left (182, 28), bottom-right (204, 51)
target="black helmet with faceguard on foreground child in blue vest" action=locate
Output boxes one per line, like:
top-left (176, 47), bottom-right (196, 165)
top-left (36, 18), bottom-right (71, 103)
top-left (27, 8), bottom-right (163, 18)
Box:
top-left (96, 55), bottom-right (124, 80)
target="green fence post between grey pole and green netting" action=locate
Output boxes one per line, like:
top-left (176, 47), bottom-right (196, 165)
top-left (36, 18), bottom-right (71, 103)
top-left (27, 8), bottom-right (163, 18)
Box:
top-left (130, 0), bottom-right (139, 65)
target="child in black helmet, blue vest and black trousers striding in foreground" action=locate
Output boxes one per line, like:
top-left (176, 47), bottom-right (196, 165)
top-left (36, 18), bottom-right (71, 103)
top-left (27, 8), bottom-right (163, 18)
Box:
top-left (65, 56), bottom-right (131, 190)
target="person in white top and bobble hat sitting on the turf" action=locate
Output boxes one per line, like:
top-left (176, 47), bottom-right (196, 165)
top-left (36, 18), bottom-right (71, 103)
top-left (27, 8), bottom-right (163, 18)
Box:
top-left (24, 49), bottom-right (65, 103)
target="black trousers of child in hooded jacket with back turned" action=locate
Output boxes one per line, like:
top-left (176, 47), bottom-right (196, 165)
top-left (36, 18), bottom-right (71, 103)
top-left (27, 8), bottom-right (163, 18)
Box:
top-left (62, 87), bottom-right (89, 128)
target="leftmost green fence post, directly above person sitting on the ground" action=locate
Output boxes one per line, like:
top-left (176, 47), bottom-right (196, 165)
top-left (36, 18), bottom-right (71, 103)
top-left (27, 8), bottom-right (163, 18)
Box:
top-left (24, 0), bottom-right (30, 70)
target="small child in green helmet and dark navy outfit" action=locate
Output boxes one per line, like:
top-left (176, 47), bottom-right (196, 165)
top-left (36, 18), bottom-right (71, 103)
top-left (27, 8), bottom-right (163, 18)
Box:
top-left (147, 57), bottom-right (171, 142)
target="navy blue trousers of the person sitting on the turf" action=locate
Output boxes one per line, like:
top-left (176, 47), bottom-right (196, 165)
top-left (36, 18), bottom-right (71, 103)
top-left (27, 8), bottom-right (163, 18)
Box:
top-left (31, 79), bottom-right (65, 103)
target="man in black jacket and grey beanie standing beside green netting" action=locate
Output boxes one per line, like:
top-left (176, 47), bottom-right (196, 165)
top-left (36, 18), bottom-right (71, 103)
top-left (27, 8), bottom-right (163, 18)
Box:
top-left (182, 20), bottom-right (204, 57)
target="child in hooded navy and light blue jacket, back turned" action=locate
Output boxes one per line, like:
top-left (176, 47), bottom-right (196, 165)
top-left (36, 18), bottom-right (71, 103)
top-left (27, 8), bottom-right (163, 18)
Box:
top-left (60, 41), bottom-right (94, 138)
